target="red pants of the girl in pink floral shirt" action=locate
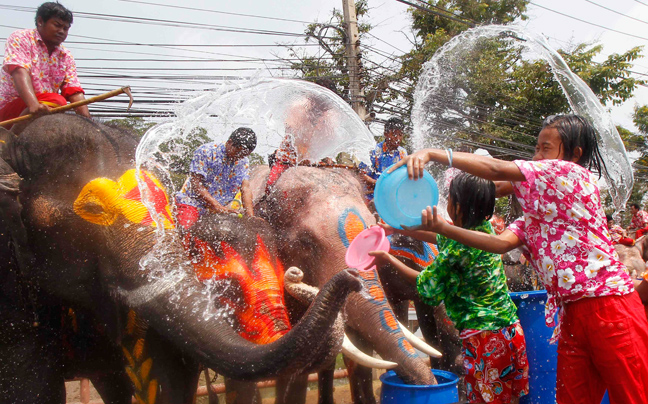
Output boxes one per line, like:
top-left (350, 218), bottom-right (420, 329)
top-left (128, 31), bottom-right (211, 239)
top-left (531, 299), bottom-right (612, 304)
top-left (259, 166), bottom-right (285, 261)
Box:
top-left (556, 293), bottom-right (648, 404)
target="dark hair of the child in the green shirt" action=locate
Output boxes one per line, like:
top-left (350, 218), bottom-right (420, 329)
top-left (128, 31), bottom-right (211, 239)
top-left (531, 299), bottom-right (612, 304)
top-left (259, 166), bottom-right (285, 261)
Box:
top-left (448, 172), bottom-right (495, 229)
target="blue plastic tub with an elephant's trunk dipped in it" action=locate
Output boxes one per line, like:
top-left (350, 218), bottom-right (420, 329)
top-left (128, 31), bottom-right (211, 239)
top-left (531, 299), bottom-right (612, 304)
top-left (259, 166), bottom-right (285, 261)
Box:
top-left (380, 369), bottom-right (459, 404)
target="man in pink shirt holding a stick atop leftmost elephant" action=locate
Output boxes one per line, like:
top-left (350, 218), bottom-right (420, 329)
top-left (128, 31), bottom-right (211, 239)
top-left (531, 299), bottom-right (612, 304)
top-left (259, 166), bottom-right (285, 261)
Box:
top-left (0, 2), bottom-right (90, 126)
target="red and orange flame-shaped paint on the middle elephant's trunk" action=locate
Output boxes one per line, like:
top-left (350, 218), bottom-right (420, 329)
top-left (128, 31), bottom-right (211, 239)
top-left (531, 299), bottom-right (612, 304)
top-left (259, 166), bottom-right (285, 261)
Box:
top-left (194, 235), bottom-right (290, 344)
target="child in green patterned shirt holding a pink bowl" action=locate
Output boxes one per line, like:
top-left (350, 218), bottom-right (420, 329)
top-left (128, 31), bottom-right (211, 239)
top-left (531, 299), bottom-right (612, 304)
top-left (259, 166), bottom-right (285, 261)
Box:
top-left (370, 173), bottom-right (529, 404)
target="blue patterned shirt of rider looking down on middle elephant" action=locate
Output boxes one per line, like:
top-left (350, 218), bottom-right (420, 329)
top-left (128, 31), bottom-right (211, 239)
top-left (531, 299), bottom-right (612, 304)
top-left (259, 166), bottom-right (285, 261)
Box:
top-left (175, 142), bottom-right (250, 215)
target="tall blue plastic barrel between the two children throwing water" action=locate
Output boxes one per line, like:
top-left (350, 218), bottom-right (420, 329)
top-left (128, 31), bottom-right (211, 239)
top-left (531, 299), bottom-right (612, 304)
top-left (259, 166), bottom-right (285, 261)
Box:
top-left (510, 290), bottom-right (609, 404)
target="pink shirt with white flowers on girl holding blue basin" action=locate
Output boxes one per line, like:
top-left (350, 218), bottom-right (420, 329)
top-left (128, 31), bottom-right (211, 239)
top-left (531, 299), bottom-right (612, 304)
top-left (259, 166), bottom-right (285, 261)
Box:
top-left (509, 160), bottom-right (634, 342)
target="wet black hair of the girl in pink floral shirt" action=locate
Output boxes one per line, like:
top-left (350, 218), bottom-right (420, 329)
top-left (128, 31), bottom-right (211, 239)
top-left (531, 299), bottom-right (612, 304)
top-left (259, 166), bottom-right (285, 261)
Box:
top-left (542, 114), bottom-right (607, 175)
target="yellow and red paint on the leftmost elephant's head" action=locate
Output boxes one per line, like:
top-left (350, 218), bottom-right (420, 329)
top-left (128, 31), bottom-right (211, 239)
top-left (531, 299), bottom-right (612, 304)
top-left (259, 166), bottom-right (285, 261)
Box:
top-left (74, 170), bottom-right (174, 229)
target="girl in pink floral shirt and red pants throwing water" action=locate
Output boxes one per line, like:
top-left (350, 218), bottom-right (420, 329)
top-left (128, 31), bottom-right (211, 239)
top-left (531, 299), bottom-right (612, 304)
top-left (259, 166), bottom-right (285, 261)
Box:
top-left (394, 115), bottom-right (648, 404)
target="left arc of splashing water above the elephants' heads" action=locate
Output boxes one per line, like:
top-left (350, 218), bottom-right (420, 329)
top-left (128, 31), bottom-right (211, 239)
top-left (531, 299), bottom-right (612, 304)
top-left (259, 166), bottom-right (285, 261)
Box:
top-left (136, 78), bottom-right (375, 321)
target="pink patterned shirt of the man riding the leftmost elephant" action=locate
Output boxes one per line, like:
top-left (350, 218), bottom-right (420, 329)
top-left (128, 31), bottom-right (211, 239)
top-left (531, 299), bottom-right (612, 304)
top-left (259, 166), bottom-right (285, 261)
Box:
top-left (0, 29), bottom-right (83, 109)
